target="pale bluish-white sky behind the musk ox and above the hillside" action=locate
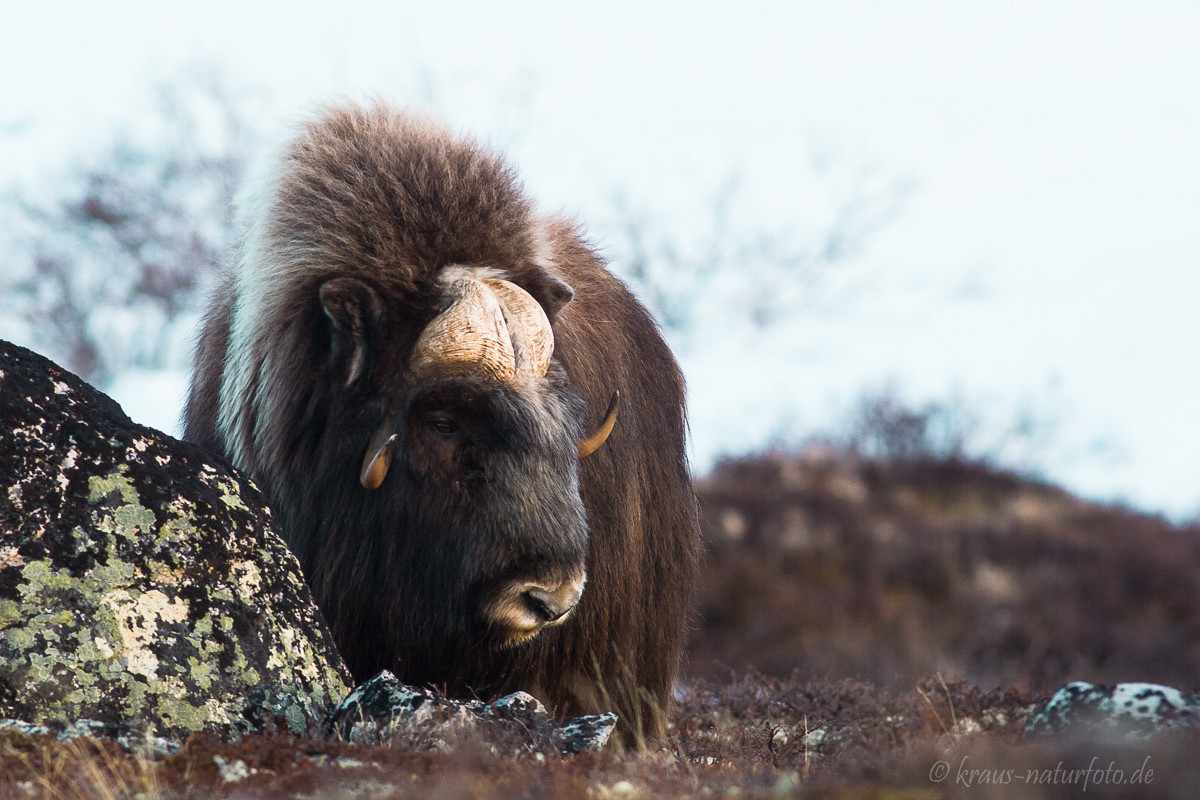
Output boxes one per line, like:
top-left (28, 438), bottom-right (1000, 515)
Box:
top-left (0, 0), bottom-right (1200, 517)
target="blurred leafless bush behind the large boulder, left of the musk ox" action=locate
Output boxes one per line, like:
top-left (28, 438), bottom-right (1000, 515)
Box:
top-left (0, 76), bottom-right (256, 385)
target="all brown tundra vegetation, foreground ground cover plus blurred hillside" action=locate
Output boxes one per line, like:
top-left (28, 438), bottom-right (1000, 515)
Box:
top-left (0, 453), bottom-right (1200, 799)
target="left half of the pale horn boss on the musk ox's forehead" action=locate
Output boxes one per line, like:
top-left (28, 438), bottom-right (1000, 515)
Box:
top-left (412, 278), bottom-right (517, 381)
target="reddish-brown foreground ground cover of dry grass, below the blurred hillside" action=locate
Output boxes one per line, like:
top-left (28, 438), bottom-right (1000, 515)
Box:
top-left (0, 675), bottom-right (1200, 800)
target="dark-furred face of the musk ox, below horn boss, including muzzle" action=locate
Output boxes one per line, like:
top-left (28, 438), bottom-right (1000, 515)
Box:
top-left (377, 375), bottom-right (587, 646)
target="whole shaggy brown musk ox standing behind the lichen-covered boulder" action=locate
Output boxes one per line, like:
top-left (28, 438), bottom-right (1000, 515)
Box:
top-left (185, 106), bottom-right (700, 736)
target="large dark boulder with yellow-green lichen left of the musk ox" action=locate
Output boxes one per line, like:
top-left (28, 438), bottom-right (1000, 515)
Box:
top-left (0, 342), bottom-right (350, 738)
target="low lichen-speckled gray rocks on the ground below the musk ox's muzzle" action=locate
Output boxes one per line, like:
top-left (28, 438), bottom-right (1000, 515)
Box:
top-left (325, 672), bottom-right (617, 754)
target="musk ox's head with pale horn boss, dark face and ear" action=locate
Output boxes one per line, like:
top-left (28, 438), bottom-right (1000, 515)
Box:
top-left (319, 266), bottom-right (616, 648)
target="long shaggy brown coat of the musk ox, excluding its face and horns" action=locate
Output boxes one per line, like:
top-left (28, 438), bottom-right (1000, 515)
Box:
top-left (185, 106), bottom-right (700, 736)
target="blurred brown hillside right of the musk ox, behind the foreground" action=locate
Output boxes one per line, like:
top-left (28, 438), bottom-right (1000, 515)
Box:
top-left (689, 447), bottom-right (1200, 690)
